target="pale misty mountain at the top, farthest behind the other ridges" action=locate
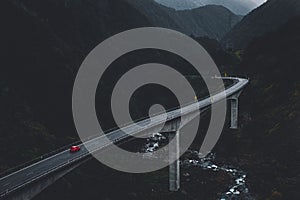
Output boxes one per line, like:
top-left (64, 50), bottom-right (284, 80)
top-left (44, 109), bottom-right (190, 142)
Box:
top-left (155, 0), bottom-right (265, 15)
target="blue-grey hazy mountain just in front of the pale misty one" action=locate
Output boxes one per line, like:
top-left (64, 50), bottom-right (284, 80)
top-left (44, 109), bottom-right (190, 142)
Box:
top-left (127, 0), bottom-right (241, 40)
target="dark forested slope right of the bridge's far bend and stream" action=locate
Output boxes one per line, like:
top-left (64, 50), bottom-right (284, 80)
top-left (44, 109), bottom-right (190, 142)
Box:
top-left (225, 16), bottom-right (300, 199)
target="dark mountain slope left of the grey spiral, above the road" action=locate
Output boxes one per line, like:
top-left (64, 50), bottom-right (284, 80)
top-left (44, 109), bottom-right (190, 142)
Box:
top-left (0, 0), bottom-right (151, 171)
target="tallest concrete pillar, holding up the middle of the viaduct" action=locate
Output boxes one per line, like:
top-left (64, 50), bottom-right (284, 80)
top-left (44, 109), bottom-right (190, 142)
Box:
top-left (168, 131), bottom-right (180, 191)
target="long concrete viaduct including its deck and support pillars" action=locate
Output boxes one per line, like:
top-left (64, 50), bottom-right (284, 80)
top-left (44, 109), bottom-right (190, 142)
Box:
top-left (0, 77), bottom-right (249, 200)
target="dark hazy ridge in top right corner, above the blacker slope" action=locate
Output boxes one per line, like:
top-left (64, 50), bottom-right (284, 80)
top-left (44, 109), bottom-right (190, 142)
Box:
top-left (222, 0), bottom-right (300, 49)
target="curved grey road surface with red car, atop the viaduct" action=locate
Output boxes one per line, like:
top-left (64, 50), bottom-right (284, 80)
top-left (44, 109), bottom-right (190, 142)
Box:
top-left (0, 78), bottom-right (249, 197)
